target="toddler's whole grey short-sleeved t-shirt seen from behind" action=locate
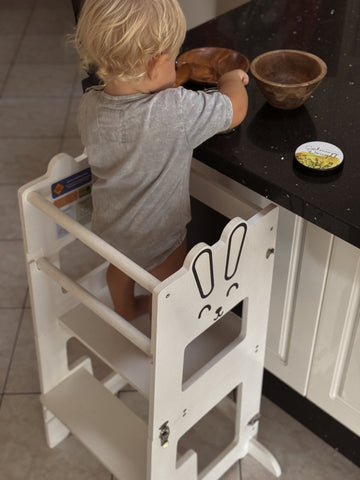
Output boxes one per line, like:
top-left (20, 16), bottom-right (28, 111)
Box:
top-left (78, 87), bottom-right (233, 269)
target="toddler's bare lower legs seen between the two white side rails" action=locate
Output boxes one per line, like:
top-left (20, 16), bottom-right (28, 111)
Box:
top-left (106, 265), bottom-right (150, 321)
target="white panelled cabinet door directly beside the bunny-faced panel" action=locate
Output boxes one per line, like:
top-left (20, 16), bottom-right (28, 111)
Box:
top-left (265, 219), bottom-right (333, 395)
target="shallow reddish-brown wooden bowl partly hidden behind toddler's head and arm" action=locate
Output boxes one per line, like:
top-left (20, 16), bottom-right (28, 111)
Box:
top-left (176, 47), bottom-right (250, 85)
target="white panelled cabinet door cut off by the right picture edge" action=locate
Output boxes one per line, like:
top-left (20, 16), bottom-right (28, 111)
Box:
top-left (308, 238), bottom-right (360, 435)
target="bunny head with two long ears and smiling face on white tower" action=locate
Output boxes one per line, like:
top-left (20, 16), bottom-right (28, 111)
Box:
top-left (192, 219), bottom-right (247, 322)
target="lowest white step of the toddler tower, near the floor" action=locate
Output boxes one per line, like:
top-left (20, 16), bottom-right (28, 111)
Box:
top-left (41, 368), bottom-right (147, 480)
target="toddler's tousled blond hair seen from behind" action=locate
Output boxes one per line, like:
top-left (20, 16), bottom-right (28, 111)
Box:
top-left (74, 0), bottom-right (186, 83)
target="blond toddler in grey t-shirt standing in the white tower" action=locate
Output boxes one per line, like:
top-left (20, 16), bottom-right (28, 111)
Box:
top-left (75, 0), bottom-right (248, 321)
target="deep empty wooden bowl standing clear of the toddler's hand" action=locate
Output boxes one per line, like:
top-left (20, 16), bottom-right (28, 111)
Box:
top-left (250, 50), bottom-right (327, 110)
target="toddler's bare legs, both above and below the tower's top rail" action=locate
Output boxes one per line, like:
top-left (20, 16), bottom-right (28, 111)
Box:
top-left (107, 240), bottom-right (186, 321)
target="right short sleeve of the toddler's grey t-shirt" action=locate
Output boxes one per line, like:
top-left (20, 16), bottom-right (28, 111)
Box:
top-left (179, 87), bottom-right (233, 148)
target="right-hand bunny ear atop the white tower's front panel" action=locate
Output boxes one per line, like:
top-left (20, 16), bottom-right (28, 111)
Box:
top-left (221, 219), bottom-right (247, 280)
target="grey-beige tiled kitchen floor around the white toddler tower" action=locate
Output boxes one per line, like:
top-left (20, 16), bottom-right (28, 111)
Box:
top-left (0, 0), bottom-right (360, 480)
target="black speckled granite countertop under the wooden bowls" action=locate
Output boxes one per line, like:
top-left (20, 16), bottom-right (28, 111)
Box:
top-left (182, 0), bottom-right (360, 248)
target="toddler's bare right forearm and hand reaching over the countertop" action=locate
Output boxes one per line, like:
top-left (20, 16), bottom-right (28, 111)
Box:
top-left (217, 69), bottom-right (249, 129)
